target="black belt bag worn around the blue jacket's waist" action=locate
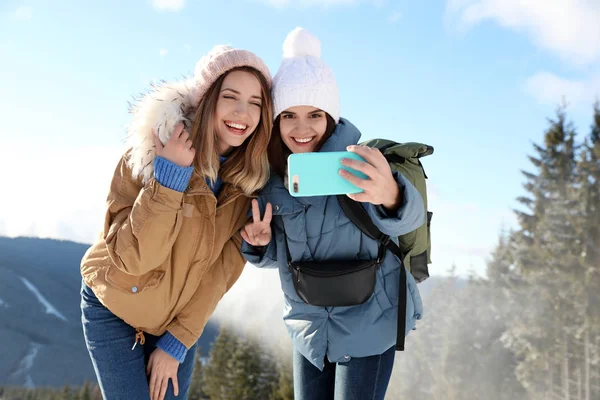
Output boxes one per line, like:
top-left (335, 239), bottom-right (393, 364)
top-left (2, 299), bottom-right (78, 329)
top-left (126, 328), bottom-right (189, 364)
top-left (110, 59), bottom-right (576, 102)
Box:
top-left (288, 239), bottom-right (385, 307)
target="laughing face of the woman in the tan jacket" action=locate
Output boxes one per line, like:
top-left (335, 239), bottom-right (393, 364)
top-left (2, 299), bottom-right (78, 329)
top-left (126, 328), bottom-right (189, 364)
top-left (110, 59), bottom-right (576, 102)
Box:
top-left (215, 70), bottom-right (262, 155)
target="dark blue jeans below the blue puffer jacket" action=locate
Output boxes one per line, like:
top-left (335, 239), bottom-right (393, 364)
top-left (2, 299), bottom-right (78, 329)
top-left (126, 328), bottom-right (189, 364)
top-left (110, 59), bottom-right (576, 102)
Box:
top-left (294, 347), bottom-right (396, 400)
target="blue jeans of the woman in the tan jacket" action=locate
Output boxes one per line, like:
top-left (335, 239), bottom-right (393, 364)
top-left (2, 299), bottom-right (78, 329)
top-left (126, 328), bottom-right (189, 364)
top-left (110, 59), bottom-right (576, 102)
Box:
top-left (81, 284), bottom-right (196, 400)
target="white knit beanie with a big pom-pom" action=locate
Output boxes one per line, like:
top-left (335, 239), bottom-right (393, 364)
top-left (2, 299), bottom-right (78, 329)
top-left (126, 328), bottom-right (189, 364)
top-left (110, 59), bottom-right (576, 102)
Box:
top-left (272, 28), bottom-right (340, 124)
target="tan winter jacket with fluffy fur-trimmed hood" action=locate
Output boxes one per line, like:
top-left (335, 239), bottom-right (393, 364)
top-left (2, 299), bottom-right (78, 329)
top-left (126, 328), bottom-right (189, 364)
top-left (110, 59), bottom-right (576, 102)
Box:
top-left (81, 80), bottom-right (251, 348)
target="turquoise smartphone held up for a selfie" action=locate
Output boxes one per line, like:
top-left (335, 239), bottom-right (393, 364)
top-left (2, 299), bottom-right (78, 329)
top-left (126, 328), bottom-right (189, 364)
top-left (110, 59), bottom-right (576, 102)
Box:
top-left (288, 151), bottom-right (368, 197)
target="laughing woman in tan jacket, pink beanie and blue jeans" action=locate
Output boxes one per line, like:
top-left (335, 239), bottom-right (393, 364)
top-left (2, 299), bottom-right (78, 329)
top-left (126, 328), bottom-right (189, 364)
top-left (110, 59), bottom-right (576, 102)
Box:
top-left (81, 46), bottom-right (273, 400)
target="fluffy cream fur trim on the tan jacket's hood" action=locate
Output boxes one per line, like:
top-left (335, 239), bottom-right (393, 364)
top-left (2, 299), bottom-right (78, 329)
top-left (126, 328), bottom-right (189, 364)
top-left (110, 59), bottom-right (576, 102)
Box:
top-left (127, 79), bottom-right (198, 184)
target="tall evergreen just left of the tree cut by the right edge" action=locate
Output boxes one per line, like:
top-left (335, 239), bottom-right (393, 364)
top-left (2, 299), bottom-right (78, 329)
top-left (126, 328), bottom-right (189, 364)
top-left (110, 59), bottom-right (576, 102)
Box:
top-left (504, 106), bottom-right (583, 398)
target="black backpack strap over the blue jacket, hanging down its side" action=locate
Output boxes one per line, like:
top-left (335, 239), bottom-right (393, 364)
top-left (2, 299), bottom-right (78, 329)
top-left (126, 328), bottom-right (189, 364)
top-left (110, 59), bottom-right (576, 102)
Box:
top-left (337, 195), bottom-right (408, 351)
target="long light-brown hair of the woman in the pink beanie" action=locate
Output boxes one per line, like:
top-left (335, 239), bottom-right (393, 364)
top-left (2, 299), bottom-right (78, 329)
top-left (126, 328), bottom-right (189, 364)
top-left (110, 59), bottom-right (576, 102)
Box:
top-left (191, 67), bottom-right (273, 195)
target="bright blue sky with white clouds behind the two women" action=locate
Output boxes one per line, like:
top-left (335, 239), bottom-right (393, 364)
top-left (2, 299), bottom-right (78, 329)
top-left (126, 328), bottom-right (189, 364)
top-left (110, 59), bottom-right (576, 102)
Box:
top-left (0, 0), bottom-right (600, 274)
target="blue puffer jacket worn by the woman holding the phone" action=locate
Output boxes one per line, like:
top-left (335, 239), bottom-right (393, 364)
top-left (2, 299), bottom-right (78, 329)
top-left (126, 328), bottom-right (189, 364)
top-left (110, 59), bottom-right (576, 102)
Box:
top-left (242, 119), bottom-right (425, 370)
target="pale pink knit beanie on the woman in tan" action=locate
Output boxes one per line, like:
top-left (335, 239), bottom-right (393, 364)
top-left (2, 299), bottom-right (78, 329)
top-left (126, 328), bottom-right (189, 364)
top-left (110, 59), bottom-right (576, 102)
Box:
top-left (194, 45), bottom-right (271, 107)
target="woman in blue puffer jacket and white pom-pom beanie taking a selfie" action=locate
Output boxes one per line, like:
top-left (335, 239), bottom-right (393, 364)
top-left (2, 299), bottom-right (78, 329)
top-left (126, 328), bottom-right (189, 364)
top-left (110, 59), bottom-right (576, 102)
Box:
top-left (241, 28), bottom-right (425, 400)
